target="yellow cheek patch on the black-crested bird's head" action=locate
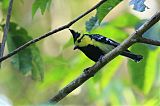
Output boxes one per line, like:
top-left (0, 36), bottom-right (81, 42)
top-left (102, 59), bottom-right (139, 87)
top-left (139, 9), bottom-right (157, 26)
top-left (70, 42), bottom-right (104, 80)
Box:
top-left (75, 36), bottom-right (93, 47)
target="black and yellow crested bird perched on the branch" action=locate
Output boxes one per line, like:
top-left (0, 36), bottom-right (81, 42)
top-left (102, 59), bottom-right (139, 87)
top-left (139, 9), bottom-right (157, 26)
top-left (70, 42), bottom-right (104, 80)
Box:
top-left (69, 29), bottom-right (143, 62)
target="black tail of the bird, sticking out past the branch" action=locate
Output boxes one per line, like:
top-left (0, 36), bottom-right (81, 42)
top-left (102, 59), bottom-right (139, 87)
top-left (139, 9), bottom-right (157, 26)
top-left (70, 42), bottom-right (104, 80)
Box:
top-left (121, 51), bottom-right (143, 62)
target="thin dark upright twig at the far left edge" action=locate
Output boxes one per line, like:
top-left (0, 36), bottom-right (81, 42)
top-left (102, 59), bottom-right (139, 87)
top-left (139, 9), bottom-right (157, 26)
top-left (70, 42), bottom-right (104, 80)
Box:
top-left (0, 0), bottom-right (13, 63)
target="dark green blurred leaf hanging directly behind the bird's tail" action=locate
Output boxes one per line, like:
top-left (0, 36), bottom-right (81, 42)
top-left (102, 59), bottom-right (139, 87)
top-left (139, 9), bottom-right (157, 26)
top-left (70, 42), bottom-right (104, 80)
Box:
top-left (128, 45), bottom-right (149, 91)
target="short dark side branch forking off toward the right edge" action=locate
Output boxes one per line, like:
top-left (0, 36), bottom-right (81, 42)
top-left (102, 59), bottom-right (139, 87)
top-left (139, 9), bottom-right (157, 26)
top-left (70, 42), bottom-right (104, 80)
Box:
top-left (137, 37), bottom-right (160, 46)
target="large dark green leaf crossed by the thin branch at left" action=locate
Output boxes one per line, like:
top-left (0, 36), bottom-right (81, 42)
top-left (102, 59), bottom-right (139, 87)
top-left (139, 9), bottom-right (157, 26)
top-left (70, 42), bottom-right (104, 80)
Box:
top-left (7, 23), bottom-right (43, 79)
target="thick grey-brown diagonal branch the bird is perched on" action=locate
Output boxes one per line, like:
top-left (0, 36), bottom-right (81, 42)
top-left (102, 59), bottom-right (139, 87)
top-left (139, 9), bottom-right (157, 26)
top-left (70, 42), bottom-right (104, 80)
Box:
top-left (49, 11), bottom-right (160, 103)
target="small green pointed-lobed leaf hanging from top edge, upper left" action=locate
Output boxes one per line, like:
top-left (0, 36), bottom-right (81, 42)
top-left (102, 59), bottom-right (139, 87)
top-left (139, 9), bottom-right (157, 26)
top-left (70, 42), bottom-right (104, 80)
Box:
top-left (32, 0), bottom-right (52, 16)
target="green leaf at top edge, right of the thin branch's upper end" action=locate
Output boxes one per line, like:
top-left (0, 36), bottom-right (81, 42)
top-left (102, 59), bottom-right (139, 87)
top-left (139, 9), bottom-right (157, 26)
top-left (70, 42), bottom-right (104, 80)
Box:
top-left (96, 0), bottom-right (123, 23)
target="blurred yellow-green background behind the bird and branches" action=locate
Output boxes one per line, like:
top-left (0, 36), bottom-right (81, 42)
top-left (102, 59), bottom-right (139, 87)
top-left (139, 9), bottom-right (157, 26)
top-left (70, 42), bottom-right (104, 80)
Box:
top-left (0, 0), bottom-right (160, 106)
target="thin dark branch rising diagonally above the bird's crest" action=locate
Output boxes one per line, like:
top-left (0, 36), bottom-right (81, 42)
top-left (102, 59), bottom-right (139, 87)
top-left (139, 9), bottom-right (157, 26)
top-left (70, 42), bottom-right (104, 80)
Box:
top-left (0, 0), bottom-right (107, 62)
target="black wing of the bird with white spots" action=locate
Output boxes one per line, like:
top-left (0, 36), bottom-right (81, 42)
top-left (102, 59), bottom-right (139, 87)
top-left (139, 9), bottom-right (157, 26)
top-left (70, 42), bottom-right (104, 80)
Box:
top-left (90, 34), bottom-right (119, 47)
